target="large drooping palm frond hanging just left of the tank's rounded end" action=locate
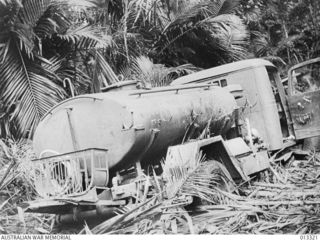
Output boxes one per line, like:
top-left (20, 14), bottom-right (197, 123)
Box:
top-left (0, 45), bottom-right (64, 136)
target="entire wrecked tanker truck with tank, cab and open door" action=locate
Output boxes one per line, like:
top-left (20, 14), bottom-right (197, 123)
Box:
top-left (27, 59), bottom-right (320, 222)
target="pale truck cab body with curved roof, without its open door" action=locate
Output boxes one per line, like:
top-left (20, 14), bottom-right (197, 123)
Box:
top-left (171, 59), bottom-right (287, 151)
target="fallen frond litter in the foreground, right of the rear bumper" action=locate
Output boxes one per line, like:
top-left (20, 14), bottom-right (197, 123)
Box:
top-left (81, 148), bottom-right (320, 234)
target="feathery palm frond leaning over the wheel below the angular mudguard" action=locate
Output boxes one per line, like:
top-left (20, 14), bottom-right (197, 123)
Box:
top-left (162, 153), bottom-right (233, 204)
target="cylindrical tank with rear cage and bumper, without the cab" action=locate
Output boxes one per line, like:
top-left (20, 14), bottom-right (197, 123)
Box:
top-left (28, 83), bottom-right (242, 222)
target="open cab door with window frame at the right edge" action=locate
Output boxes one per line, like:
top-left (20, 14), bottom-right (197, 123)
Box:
top-left (288, 58), bottom-right (320, 140)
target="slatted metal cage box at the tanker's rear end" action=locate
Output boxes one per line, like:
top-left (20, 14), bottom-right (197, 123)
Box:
top-left (33, 149), bottom-right (109, 199)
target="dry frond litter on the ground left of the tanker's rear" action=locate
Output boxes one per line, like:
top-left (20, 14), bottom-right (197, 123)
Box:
top-left (0, 141), bottom-right (54, 234)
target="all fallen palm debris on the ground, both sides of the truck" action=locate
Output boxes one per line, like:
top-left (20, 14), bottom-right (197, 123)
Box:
top-left (0, 140), bottom-right (320, 234)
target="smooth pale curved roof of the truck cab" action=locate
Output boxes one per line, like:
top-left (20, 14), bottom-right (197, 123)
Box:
top-left (171, 59), bottom-right (275, 85)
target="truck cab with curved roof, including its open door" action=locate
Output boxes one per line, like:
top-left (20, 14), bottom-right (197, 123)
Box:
top-left (171, 58), bottom-right (320, 151)
